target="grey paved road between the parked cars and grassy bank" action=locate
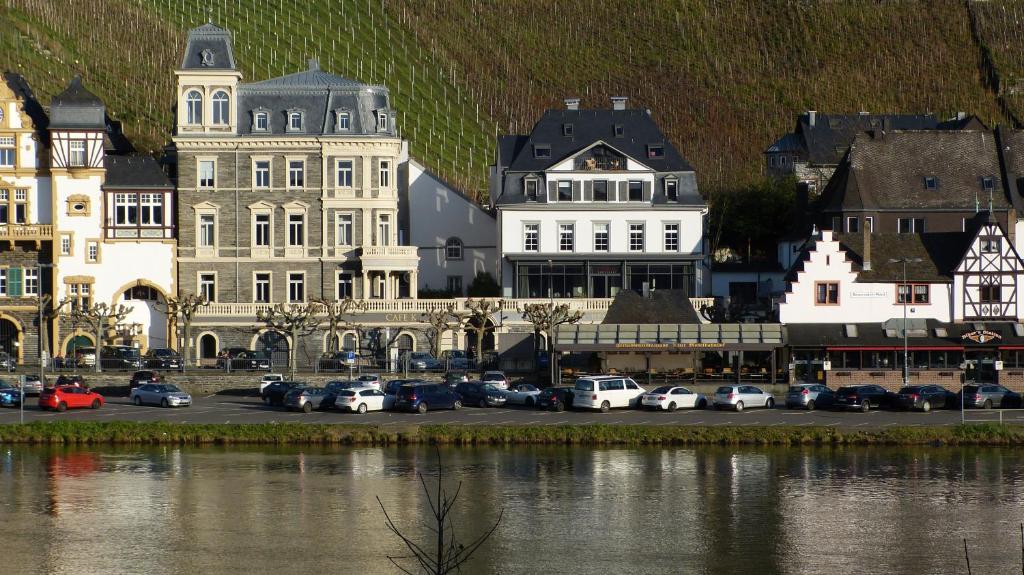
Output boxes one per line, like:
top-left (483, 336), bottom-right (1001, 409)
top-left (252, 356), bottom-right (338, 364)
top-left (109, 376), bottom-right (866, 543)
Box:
top-left (0, 395), bottom-right (1024, 429)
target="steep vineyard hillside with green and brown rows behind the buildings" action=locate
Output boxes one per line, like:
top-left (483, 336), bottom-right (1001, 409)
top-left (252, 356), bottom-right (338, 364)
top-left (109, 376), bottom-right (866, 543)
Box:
top-left (0, 0), bottom-right (1024, 198)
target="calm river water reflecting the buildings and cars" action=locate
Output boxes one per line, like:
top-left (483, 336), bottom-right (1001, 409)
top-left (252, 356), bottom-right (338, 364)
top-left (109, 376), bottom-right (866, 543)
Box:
top-left (0, 447), bottom-right (1024, 575)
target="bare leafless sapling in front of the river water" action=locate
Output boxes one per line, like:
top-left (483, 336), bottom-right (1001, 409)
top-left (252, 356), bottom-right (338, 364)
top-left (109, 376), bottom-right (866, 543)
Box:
top-left (377, 447), bottom-right (505, 575)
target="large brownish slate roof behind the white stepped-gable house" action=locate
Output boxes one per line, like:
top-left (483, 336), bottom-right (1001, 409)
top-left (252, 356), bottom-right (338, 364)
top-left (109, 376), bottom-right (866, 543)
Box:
top-left (819, 130), bottom-right (1014, 212)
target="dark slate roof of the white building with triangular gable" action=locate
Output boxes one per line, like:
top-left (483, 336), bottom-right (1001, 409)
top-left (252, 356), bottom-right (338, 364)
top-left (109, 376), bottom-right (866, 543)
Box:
top-left (499, 109), bottom-right (693, 172)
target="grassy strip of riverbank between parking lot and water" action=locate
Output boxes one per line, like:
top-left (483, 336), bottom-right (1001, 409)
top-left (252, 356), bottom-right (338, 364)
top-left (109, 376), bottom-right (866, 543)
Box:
top-left (0, 422), bottom-right (1024, 446)
